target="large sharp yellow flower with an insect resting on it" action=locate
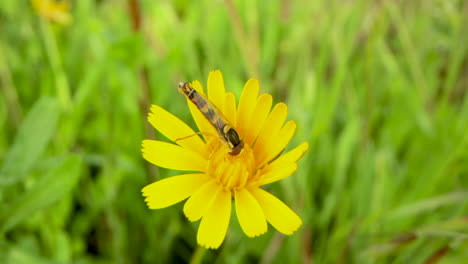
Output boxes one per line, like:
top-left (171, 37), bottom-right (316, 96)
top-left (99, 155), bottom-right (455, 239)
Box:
top-left (142, 71), bottom-right (308, 249)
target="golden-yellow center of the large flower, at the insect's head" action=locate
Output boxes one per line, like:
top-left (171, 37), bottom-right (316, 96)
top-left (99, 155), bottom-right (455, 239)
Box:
top-left (207, 140), bottom-right (257, 191)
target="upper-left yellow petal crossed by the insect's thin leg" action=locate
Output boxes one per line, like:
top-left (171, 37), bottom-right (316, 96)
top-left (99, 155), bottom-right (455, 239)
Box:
top-left (148, 105), bottom-right (208, 158)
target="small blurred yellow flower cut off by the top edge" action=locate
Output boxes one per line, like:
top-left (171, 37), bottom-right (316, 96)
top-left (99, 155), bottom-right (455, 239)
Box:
top-left (31, 0), bottom-right (72, 25)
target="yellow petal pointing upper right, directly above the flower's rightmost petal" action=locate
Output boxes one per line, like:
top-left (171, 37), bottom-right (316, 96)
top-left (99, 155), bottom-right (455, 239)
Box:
top-left (257, 120), bottom-right (296, 167)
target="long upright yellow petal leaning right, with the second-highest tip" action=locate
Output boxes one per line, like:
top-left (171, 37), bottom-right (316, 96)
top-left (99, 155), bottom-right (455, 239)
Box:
top-left (236, 79), bottom-right (260, 138)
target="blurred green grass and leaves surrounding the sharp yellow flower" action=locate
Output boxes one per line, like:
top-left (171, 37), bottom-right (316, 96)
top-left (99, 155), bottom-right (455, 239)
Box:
top-left (0, 0), bottom-right (468, 264)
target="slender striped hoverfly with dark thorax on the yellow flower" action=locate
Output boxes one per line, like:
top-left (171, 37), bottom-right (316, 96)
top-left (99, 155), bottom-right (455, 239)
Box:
top-left (179, 82), bottom-right (244, 156)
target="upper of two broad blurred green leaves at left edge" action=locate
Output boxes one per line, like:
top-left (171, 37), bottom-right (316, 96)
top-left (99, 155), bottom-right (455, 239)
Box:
top-left (0, 97), bottom-right (59, 188)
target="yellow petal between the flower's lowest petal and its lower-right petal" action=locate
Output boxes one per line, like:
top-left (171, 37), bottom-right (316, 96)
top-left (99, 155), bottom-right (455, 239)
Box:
top-left (235, 188), bottom-right (267, 237)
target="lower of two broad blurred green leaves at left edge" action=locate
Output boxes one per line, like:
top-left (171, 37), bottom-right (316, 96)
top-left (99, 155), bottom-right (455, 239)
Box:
top-left (0, 155), bottom-right (82, 232)
